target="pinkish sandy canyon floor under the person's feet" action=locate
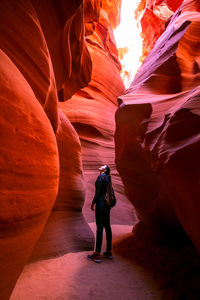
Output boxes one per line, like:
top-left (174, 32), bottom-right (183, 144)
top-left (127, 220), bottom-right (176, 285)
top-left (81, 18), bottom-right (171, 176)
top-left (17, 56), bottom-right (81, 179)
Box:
top-left (10, 223), bottom-right (162, 300)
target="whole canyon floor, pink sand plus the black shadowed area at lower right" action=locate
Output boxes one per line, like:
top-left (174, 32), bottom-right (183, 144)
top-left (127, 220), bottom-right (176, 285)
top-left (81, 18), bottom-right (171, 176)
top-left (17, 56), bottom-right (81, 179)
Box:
top-left (10, 202), bottom-right (200, 300)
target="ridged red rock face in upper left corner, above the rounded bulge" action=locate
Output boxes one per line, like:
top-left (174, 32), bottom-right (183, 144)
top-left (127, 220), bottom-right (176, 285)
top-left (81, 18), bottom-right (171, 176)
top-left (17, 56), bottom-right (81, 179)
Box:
top-left (0, 0), bottom-right (58, 131)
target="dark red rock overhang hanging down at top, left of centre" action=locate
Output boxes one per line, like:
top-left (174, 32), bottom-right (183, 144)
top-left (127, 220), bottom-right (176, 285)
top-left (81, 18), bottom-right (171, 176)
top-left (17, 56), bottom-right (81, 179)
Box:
top-left (30, 0), bottom-right (92, 101)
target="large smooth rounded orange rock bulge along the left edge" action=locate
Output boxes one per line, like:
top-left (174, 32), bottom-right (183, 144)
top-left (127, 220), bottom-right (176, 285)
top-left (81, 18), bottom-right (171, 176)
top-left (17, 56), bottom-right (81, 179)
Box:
top-left (0, 51), bottom-right (59, 299)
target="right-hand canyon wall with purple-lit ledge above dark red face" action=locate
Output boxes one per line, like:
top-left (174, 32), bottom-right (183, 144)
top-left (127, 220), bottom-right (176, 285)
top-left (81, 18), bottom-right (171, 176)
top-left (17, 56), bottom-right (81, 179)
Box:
top-left (115, 1), bottom-right (200, 251)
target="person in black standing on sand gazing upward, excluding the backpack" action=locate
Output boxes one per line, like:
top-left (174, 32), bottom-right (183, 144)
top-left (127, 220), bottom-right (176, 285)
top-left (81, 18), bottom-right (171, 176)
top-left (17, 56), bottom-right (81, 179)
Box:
top-left (88, 165), bottom-right (113, 263)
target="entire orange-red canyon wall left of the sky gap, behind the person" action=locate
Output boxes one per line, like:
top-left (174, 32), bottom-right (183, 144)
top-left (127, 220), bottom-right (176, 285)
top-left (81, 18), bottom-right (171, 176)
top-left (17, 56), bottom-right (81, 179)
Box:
top-left (0, 0), bottom-right (134, 299)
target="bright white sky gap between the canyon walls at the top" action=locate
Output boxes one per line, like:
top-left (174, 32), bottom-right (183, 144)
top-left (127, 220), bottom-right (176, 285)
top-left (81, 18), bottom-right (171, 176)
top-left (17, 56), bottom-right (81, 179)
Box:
top-left (114, 0), bottom-right (142, 88)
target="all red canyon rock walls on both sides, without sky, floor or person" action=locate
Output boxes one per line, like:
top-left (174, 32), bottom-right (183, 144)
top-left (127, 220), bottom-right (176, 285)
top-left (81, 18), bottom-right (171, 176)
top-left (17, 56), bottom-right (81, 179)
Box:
top-left (0, 0), bottom-right (200, 299)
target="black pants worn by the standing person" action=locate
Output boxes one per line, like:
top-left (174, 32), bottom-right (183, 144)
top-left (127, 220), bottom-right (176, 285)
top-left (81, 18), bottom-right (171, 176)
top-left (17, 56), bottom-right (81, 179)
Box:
top-left (95, 201), bottom-right (112, 253)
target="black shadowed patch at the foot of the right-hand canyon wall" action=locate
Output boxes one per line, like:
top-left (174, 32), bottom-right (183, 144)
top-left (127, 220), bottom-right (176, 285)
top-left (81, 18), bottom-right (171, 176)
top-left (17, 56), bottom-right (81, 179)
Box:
top-left (114, 228), bottom-right (200, 300)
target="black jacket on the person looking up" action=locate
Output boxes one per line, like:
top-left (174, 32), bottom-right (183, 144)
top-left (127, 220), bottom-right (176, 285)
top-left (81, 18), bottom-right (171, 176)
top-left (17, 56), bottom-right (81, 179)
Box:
top-left (92, 173), bottom-right (108, 204)
